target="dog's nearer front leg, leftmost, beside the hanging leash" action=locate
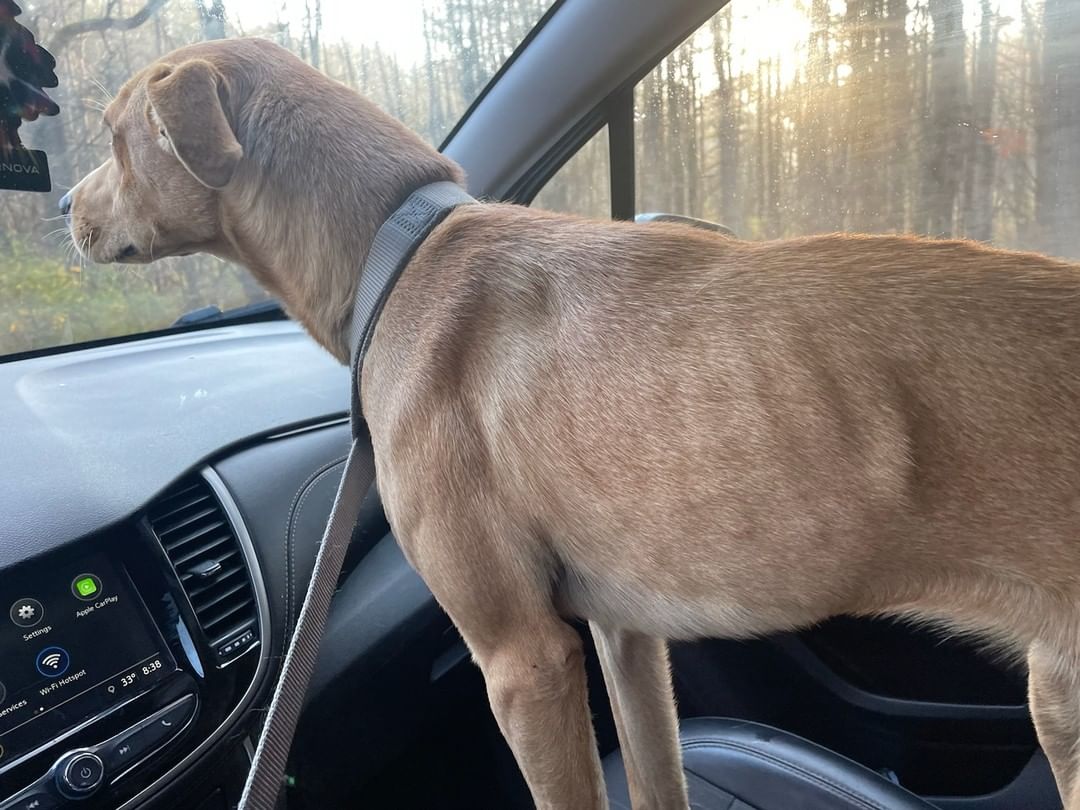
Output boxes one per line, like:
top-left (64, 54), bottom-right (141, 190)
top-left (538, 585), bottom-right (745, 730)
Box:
top-left (402, 516), bottom-right (608, 810)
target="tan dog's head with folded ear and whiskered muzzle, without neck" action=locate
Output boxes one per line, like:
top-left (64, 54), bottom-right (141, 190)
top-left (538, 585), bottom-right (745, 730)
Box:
top-left (60, 51), bottom-right (243, 262)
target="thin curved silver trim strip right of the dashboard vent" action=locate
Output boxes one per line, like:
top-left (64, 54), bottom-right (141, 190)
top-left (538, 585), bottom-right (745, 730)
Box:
top-left (117, 467), bottom-right (271, 810)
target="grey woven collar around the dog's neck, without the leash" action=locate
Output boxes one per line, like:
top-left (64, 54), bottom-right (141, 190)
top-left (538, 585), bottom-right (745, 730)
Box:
top-left (349, 180), bottom-right (476, 434)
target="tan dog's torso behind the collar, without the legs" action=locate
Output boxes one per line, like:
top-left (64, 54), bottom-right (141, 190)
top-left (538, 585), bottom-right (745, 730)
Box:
top-left (365, 206), bottom-right (1080, 644)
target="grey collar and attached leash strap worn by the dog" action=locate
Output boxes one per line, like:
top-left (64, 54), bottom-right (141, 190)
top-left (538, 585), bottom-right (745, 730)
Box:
top-left (238, 181), bottom-right (475, 810)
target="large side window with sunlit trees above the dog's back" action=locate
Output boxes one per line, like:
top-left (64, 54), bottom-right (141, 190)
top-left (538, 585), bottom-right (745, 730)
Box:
top-left (635, 0), bottom-right (1080, 257)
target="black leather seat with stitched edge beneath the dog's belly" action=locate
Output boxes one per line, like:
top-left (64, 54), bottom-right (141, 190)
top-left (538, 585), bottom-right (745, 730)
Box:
top-left (604, 717), bottom-right (934, 810)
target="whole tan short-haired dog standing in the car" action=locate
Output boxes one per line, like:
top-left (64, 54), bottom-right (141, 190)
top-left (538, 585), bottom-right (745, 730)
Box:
top-left (65, 40), bottom-right (1080, 810)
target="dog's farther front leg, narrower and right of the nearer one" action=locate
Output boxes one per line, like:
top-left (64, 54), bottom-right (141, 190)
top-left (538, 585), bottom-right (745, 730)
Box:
top-left (589, 622), bottom-right (687, 810)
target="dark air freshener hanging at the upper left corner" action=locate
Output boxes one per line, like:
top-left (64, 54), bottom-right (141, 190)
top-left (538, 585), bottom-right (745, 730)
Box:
top-left (0, 0), bottom-right (60, 191)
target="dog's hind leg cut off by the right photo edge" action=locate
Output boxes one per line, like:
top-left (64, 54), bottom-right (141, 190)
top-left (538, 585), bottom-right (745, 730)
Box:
top-left (1027, 642), bottom-right (1080, 810)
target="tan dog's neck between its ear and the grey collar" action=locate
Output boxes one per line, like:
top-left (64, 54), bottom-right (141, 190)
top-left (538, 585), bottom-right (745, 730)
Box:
top-left (220, 75), bottom-right (463, 363)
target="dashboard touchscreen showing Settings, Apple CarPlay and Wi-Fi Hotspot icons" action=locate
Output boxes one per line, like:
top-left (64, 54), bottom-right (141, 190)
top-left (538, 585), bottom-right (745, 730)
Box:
top-left (0, 554), bottom-right (176, 770)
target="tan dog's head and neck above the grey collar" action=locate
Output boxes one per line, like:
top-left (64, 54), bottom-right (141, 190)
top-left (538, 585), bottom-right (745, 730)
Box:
top-left (60, 38), bottom-right (463, 359)
